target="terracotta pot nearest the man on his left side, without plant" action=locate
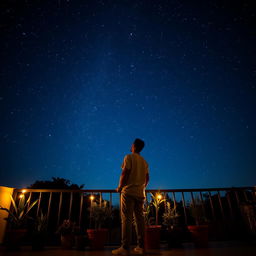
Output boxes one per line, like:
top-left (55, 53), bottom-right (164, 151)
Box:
top-left (87, 229), bottom-right (108, 250)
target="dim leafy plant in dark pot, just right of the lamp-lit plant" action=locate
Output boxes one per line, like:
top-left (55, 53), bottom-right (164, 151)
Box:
top-left (163, 202), bottom-right (183, 247)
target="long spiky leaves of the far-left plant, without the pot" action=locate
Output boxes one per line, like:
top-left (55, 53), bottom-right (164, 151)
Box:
top-left (0, 193), bottom-right (38, 229)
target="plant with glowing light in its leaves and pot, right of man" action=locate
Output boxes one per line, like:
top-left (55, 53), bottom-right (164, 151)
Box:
top-left (145, 193), bottom-right (165, 249)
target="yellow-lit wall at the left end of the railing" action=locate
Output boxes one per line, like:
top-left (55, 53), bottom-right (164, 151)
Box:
top-left (0, 186), bottom-right (14, 244)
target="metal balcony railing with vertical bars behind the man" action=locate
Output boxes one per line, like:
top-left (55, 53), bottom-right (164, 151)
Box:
top-left (8, 187), bottom-right (256, 243)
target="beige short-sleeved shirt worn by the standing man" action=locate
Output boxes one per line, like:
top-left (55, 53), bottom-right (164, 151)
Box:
top-left (121, 153), bottom-right (148, 198)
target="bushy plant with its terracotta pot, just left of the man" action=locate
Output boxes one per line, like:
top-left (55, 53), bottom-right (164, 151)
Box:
top-left (87, 201), bottom-right (112, 249)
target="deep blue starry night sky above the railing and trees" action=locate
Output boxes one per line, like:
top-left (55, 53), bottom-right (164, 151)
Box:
top-left (0, 0), bottom-right (256, 189)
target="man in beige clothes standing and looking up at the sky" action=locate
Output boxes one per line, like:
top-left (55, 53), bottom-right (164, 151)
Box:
top-left (112, 139), bottom-right (149, 255)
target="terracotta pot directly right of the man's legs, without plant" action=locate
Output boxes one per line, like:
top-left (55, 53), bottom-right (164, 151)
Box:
top-left (145, 225), bottom-right (161, 249)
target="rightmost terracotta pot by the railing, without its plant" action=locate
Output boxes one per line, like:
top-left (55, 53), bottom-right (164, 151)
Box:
top-left (188, 225), bottom-right (209, 247)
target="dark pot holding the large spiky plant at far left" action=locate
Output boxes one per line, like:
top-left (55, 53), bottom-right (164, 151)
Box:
top-left (5, 229), bottom-right (27, 250)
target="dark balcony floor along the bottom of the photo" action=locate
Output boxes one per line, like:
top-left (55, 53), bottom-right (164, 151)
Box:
top-left (0, 241), bottom-right (256, 256)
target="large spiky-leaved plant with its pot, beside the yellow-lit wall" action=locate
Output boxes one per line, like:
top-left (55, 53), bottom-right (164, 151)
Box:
top-left (0, 193), bottom-right (38, 250)
